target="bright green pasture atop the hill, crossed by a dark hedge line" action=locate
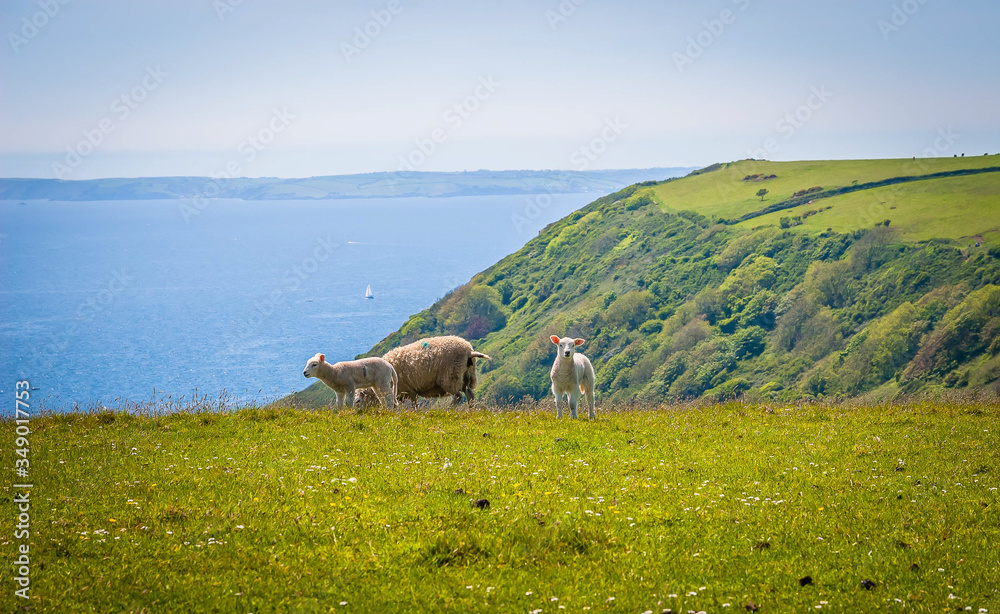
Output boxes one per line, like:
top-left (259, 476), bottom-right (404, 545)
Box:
top-left (653, 155), bottom-right (1000, 240)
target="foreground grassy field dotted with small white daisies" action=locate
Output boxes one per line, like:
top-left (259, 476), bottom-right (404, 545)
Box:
top-left (2, 402), bottom-right (1000, 612)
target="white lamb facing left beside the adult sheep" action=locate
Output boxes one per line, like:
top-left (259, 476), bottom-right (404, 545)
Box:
top-left (302, 354), bottom-right (399, 409)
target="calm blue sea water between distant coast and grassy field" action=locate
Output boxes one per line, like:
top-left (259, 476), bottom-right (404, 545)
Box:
top-left (0, 193), bottom-right (600, 415)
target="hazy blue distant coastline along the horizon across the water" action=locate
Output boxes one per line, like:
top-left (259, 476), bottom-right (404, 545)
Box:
top-left (0, 167), bottom-right (694, 201)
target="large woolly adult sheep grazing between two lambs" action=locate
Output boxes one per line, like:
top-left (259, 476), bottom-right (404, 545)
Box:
top-left (358, 336), bottom-right (491, 407)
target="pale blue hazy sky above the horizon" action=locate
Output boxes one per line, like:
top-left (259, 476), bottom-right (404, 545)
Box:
top-left (0, 0), bottom-right (1000, 179)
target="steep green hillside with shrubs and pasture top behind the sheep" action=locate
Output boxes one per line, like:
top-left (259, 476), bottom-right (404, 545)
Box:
top-left (295, 156), bottom-right (1000, 404)
